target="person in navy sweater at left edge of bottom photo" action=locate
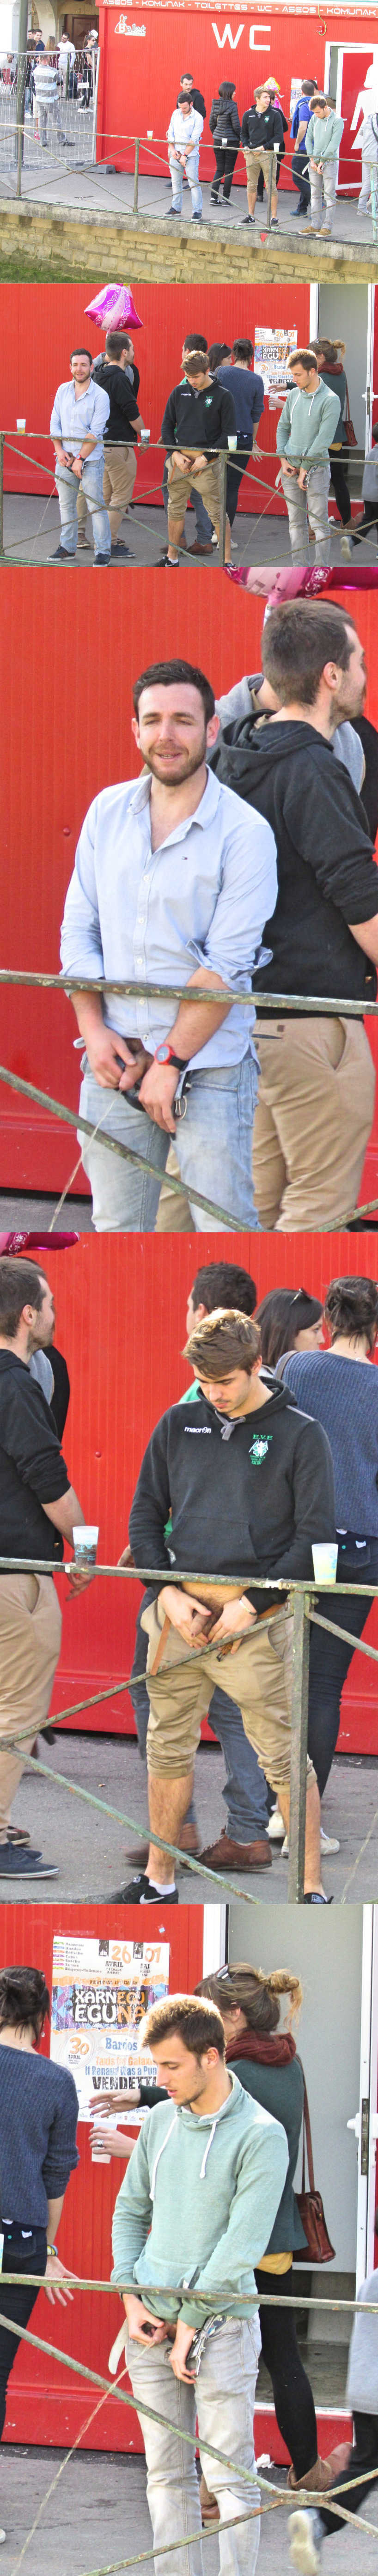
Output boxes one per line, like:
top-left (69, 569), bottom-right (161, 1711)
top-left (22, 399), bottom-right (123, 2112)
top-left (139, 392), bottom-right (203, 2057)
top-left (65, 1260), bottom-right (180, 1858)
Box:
top-left (0, 1966), bottom-right (80, 2540)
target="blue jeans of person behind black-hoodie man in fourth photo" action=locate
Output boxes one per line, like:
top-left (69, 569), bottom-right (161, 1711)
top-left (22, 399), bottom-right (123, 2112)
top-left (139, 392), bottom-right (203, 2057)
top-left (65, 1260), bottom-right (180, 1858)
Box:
top-left (128, 1602), bottom-right (268, 1842)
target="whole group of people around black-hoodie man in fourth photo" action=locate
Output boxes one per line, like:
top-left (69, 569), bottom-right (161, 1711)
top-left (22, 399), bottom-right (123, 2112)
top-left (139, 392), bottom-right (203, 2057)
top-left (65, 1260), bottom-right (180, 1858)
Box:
top-left (0, 1255), bottom-right (378, 1904)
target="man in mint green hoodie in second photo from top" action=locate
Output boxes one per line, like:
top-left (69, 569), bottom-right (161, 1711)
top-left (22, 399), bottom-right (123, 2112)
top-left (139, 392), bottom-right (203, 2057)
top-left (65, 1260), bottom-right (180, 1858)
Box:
top-left (278, 348), bottom-right (340, 564)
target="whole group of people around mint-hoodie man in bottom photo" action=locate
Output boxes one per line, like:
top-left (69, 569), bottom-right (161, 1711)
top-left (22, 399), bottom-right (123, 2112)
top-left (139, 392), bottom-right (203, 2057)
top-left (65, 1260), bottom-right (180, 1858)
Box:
top-left (0, 1963), bottom-right (378, 2576)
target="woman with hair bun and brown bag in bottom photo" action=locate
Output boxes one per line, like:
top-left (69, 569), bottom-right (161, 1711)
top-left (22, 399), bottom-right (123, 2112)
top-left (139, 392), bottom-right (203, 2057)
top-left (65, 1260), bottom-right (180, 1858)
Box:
top-left (195, 1963), bottom-right (332, 2519)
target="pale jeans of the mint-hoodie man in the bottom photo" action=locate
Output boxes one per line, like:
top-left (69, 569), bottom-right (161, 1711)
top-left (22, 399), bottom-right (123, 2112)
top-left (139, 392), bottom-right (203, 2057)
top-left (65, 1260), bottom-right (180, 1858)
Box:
top-left (126, 2313), bottom-right (260, 2576)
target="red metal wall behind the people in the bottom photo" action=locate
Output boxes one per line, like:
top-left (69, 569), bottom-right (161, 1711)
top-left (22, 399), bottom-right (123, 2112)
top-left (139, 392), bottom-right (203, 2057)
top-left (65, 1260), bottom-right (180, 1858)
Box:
top-left (0, 1901), bottom-right (203, 2450)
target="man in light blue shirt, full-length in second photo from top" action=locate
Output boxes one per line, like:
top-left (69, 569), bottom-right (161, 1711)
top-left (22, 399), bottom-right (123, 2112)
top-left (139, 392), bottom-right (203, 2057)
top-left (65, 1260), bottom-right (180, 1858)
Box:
top-left (49, 348), bottom-right (110, 564)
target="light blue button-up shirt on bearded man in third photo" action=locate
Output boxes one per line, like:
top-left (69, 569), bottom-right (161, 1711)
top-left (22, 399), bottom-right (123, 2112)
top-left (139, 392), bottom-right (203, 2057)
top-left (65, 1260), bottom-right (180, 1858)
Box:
top-left (62, 770), bottom-right (278, 1066)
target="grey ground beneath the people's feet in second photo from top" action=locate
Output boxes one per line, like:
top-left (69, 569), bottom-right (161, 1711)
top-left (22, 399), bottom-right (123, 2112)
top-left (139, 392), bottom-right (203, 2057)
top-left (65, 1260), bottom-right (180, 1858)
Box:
top-left (3, 492), bottom-right (378, 572)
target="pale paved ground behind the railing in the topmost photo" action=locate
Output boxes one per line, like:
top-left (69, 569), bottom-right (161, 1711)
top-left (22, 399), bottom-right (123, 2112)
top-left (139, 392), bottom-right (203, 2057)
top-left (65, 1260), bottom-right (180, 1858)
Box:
top-left (0, 152), bottom-right (373, 258)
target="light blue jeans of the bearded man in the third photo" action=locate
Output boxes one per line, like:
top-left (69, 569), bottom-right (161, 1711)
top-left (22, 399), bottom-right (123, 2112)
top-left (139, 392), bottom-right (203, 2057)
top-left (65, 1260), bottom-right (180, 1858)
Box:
top-left (80, 1056), bottom-right (257, 1234)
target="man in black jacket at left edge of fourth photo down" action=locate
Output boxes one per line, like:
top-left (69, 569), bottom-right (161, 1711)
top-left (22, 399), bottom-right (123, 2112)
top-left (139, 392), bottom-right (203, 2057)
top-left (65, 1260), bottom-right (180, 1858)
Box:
top-left (0, 1255), bottom-right (90, 1891)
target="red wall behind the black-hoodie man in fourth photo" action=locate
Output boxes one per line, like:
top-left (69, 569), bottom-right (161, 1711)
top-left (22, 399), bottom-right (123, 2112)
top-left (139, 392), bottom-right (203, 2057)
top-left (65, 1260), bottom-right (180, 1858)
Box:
top-left (24, 1234), bottom-right (378, 1751)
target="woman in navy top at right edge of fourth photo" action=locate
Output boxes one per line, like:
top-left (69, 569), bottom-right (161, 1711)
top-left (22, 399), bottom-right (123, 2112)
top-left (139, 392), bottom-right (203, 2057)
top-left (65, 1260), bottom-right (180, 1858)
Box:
top-left (283, 1278), bottom-right (378, 1796)
